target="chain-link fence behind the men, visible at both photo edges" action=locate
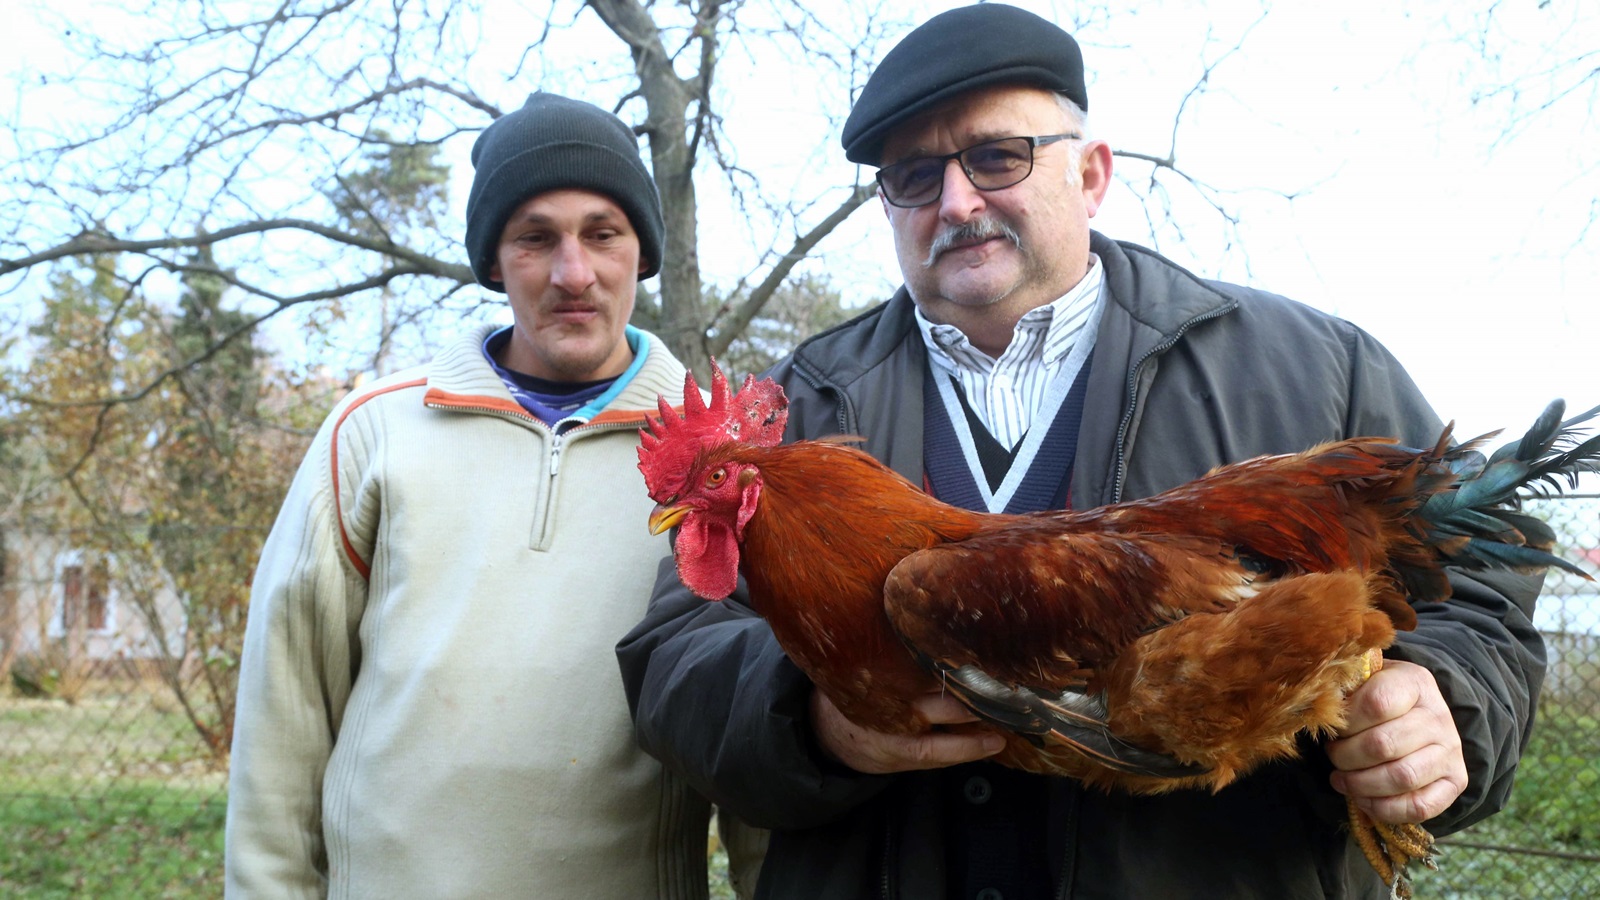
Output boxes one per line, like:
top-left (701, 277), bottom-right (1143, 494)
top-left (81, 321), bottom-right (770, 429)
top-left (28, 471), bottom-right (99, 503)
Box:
top-left (0, 496), bottom-right (1600, 898)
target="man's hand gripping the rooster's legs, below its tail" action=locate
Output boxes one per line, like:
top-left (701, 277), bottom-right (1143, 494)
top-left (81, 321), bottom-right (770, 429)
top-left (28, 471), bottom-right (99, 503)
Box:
top-left (1328, 660), bottom-right (1467, 825)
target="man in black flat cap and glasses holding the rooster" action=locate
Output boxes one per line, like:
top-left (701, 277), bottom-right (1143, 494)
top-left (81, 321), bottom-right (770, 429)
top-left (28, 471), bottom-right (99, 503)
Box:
top-left (618, 3), bottom-right (1544, 900)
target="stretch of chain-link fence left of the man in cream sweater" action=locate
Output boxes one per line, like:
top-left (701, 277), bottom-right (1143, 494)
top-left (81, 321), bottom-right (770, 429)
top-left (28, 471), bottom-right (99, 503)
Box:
top-left (0, 530), bottom-right (232, 898)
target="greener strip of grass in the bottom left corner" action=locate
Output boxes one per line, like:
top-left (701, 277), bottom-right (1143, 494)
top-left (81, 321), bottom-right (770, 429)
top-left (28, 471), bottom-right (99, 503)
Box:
top-left (0, 788), bottom-right (226, 900)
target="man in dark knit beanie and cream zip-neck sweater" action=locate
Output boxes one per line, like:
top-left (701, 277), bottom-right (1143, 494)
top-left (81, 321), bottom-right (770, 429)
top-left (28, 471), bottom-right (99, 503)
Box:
top-left (227, 93), bottom-right (736, 900)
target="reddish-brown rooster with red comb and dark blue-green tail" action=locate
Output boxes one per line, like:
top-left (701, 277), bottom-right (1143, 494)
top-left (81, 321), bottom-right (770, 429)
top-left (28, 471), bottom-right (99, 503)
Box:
top-left (638, 360), bottom-right (1600, 895)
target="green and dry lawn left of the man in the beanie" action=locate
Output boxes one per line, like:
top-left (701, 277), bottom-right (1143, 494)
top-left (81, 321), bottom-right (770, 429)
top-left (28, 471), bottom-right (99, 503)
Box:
top-left (0, 682), bottom-right (226, 900)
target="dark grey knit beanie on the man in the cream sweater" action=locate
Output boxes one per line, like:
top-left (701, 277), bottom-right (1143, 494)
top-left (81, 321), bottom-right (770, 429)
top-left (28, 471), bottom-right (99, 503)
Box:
top-left (467, 91), bottom-right (666, 286)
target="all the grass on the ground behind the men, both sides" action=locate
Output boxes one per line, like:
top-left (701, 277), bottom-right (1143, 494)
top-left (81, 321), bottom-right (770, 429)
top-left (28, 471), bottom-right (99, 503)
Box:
top-left (0, 685), bottom-right (1600, 900)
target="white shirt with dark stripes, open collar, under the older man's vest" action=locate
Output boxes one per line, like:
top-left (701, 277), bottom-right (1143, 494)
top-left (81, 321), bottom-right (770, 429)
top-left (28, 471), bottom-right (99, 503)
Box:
top-left (917, 253), bottom-right (1104, 448)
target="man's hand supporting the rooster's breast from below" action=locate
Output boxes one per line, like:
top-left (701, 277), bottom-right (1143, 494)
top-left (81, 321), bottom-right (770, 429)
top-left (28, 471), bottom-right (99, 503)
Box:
top-left (811, 689), bottom-right (1005, 775)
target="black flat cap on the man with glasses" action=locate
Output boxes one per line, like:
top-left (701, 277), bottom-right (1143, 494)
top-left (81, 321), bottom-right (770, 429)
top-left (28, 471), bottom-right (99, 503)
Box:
top-left (842, 3), bottom-right (1090, 165)
